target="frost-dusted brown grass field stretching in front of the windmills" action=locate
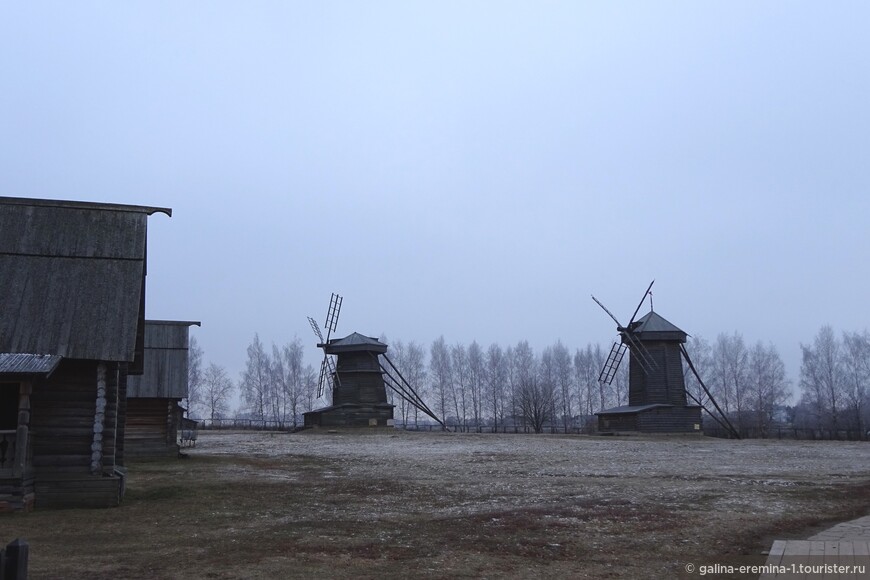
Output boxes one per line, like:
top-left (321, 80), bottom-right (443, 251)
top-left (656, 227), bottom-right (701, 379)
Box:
top-left (0, 431), bottom-right (870, 579)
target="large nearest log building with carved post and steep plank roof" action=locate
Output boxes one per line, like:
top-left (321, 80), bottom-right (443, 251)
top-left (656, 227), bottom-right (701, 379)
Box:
top-left (0, 197), bottom-right (172, 511)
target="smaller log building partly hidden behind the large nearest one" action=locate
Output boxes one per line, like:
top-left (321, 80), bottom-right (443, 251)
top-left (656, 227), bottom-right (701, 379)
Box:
top-left (124, 320), bottom-right (200, 459)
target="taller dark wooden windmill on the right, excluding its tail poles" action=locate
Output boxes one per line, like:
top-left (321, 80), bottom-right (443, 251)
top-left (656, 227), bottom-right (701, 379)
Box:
top-left (592, 280), bottom-right (702, 433)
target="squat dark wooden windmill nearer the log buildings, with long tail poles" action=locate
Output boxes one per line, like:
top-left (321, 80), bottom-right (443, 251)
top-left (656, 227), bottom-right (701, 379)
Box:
top-left (304, 294), bottom-right (444, 427)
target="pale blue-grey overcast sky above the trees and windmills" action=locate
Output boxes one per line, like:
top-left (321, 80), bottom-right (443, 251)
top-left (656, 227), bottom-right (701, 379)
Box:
top-left (0, 0), bottom-right (870, 396)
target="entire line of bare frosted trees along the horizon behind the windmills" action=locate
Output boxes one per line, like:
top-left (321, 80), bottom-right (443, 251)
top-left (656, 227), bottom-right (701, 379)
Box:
top-left (188, 326), bottom-right (870, 438)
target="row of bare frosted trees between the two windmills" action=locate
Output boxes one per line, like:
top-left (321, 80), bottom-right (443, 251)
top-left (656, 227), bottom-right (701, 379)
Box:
top-left (390, 336), bottom-right (628, 431)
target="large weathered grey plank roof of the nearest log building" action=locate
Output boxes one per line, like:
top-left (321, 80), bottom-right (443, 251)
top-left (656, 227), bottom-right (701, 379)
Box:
top-left (0, 197), bottom-right (172, 362)
